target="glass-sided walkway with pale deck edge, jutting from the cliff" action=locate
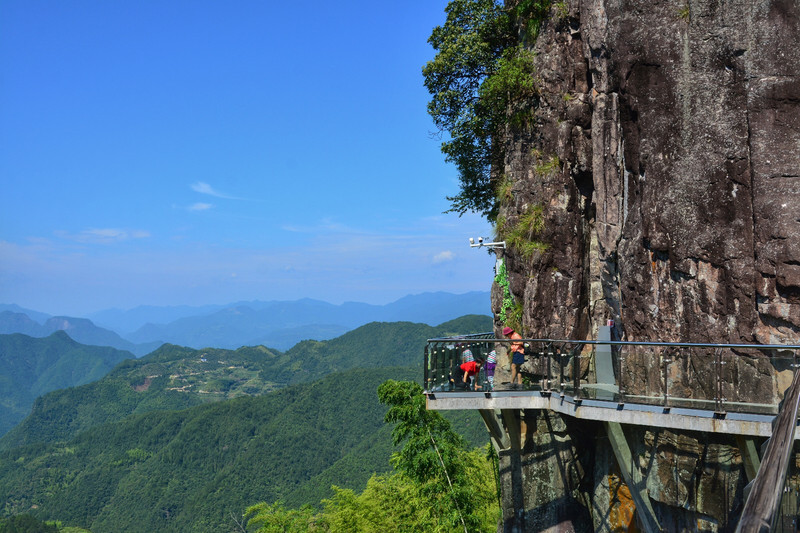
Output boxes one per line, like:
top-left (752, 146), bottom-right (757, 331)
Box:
top-left (424, 334), bottom-right (800, 532)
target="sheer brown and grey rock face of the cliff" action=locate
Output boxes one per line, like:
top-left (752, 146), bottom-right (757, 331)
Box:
top-left (493, 0), bottom-right (800, 531)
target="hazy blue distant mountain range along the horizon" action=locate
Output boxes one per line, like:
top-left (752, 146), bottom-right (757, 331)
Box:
top-left (0, 291), bottom-right (490, 356)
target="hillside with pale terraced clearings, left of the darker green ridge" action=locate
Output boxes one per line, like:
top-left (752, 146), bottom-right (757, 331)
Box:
top-left (0, 345), bottom-right (284, 449)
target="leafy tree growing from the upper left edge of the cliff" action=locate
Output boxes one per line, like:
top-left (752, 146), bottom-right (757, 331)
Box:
top-left (422, 0), bottom-right (551, 222)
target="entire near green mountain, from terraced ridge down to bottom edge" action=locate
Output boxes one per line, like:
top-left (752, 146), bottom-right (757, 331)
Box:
top-left (0, 316), bottom-right (491, 533)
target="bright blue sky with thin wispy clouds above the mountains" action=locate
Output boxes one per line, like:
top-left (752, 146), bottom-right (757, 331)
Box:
top-left (0, 0), bottom-right (493, 316)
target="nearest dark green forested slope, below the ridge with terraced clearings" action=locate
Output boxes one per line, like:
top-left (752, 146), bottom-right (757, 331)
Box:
top-left (0, 368), bottom-right (488, 533)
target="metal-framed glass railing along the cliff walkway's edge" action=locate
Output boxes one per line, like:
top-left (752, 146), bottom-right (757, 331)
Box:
top-left (424, 333), bottom-right (800, 415)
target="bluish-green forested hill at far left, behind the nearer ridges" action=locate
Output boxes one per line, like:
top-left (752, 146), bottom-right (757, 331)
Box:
top-left (0, 331), bottom-right (133, 435)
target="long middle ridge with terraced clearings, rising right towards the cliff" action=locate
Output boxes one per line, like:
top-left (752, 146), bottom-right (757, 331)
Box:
top-left (0, 315), bottom-right (491, 449)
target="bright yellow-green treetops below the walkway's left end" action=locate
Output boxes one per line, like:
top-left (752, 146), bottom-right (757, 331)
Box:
top-left (243, 380), bottom-right (500, 533)
